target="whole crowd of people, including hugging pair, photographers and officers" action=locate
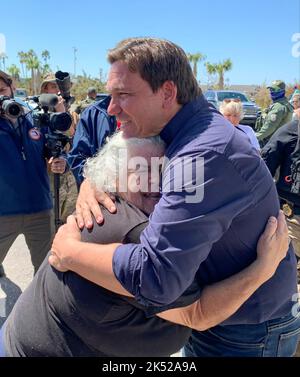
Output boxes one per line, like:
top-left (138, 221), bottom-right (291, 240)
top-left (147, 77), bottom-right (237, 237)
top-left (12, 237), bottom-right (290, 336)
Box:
top-left (0, 38), bottom-right (300, 357)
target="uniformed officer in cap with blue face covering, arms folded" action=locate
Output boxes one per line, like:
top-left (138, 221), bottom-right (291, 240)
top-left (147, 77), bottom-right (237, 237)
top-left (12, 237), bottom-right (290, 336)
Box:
top-left (255, 80), bottom-right (293, 146)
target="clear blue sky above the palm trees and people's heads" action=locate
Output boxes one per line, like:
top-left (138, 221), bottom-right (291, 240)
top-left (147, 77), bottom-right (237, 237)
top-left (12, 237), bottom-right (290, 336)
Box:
top-left (0, 0), bottom-right (300, 85)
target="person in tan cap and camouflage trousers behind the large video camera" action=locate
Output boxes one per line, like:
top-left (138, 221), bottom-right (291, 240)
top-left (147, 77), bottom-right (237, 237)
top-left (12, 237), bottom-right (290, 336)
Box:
top-left (41, 73), bottom-right (78, 222)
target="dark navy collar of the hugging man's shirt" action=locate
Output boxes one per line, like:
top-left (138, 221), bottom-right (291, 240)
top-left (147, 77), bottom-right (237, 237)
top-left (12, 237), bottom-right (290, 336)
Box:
top-left (160, 95), bottom-right (209, 145)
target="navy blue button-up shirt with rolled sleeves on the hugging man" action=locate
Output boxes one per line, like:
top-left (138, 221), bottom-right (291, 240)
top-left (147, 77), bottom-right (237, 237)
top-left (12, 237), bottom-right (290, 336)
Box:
top-left (113, 96), bottom-right (297, 324)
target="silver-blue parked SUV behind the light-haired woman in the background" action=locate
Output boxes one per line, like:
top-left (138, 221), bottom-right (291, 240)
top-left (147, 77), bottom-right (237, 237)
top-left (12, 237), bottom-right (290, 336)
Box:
top-left (204, 90), bottom-right (261, 127)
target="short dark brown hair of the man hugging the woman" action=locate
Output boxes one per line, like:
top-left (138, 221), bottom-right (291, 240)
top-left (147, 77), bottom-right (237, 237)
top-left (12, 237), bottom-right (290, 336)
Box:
top-left (108, 38), bottom-right (202, 105)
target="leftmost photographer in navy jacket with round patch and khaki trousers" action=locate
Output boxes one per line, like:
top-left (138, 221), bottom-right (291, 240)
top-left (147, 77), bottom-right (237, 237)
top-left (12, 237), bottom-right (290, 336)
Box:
top-left (0, 71), bottom-right (60, 276)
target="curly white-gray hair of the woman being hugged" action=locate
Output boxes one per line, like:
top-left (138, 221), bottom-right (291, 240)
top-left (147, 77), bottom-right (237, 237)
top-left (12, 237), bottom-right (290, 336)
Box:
top-left (83, 131), bottom-right (165, 193)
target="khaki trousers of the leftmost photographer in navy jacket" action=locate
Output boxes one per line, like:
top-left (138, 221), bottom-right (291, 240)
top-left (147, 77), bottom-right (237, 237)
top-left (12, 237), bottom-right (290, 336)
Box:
top-left (0, 211), bottom-right (54, 273)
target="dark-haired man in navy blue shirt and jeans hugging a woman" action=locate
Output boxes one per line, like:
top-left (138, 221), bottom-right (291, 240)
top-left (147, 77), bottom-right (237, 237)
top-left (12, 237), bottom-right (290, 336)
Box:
top-left (49, 38), bottom-right (300, 356)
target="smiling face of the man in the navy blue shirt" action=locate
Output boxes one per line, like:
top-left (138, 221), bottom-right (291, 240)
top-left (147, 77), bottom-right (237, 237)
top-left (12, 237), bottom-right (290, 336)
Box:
top-left (107, 61), bottom-right (173, 138)
